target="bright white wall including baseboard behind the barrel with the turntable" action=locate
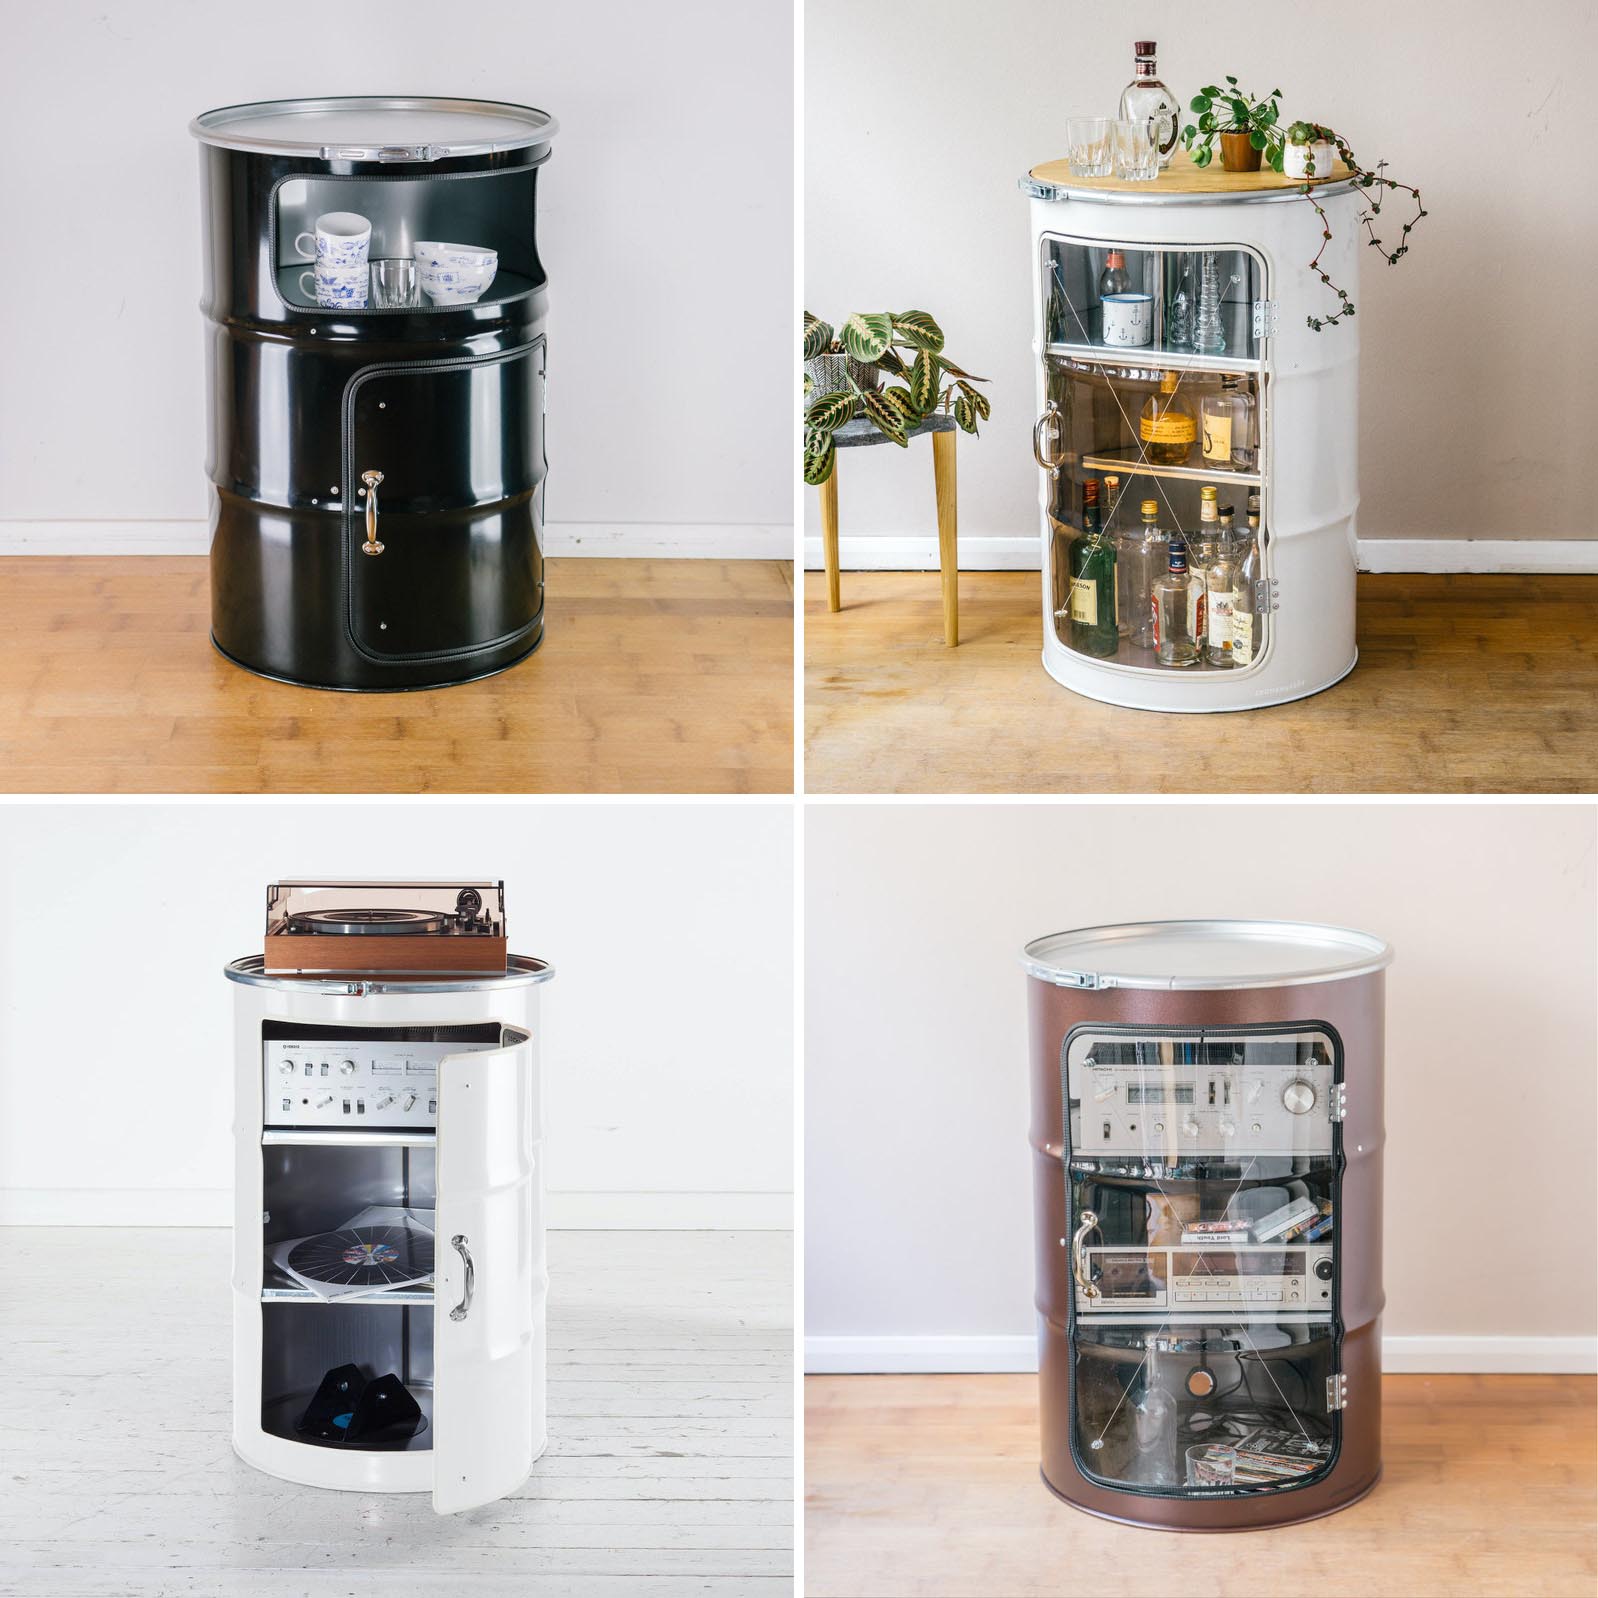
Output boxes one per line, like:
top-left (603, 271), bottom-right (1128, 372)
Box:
top-left (0, 799), bottom-right (793, 1227)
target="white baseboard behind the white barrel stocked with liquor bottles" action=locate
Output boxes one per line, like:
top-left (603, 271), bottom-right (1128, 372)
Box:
top-left (804, 535), bottom-right (1598, 572)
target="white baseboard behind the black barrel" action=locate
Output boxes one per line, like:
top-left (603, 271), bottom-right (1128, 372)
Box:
top-left (0, 521), bottom-right (794, 561)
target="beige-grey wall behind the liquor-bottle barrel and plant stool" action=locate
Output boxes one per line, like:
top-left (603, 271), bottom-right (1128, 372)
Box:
top-left (804, 0), bottom-right (1598, 564)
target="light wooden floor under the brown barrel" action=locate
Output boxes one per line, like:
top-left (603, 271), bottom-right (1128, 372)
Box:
top-left (805, 1376), bottom-right (1598, 1598)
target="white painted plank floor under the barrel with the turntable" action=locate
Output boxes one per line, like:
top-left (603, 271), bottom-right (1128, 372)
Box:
top-left (0, 1227), bottom-right (794, 1598)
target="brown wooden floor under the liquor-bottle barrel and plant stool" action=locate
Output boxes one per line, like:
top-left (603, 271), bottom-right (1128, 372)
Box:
top-left (805, 572), bottom-right (1598, 793)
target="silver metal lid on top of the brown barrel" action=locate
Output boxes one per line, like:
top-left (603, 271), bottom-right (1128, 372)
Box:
top-left (1021, 920), bottom-right (1393, 991)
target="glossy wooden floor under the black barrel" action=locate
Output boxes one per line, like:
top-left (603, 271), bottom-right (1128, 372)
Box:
top-left (0, 556), bottom-right (794, 793)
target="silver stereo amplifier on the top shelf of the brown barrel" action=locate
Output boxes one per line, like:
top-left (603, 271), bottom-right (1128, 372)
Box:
top-left (1066, 1037), bottom-right (1334, 1163)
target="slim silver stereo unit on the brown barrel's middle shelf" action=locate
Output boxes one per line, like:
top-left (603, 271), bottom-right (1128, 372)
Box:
top-left (1077, 1243), bottom-right (1333, 1315)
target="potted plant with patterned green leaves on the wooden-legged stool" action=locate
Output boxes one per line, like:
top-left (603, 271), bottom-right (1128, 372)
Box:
top-left (804, 310), bottom-right (991, 484)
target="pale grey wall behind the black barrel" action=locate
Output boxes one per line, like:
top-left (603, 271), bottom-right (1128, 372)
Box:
top-left (0, 0), bottom-right (794, 556)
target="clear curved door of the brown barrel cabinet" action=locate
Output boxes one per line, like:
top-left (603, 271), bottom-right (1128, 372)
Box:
top-left (1061, 1026), bottom-right (1342, 1496)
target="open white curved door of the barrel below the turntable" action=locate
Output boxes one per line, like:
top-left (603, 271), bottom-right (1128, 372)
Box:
top-left (433, 1028), bottom-right (545, 1513)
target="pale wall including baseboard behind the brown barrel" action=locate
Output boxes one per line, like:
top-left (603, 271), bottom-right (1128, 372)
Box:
top-left (804, 799), bottom-right (1598, 1369)
